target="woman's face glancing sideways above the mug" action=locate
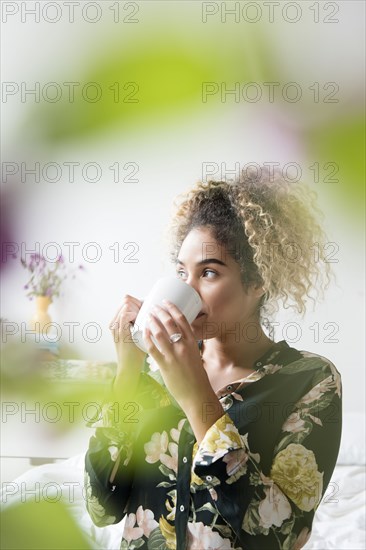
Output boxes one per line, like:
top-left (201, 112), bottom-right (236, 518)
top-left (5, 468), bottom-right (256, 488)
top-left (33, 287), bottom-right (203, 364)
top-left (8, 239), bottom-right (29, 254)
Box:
top-left (176, 227), bottom-right (263, 341)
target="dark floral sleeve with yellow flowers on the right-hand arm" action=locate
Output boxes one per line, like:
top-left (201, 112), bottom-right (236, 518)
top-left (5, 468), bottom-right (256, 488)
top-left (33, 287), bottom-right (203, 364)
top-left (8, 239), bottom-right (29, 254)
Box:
top-left (193, 362), bottom-right (342, 550)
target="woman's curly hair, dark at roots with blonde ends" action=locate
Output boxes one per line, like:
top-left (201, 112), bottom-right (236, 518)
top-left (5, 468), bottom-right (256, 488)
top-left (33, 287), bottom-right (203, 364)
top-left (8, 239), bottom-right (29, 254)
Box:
top-left (167, 166), bottom-right (332, 315)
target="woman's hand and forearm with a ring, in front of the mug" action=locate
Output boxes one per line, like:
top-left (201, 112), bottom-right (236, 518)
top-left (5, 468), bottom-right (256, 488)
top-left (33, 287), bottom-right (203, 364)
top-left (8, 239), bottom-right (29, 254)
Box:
top-left (144, 300), bottom-right (222, 416)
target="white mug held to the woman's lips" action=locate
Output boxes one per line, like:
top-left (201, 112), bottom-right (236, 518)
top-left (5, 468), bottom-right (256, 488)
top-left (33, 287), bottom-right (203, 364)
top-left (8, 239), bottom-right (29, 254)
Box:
top-left (130, 275), bottom-right (202, 353)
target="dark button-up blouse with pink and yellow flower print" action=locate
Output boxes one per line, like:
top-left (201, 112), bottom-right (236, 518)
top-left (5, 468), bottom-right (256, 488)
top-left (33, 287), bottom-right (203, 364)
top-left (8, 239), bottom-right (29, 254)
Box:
top-left (85, 340), bottom-right (342, 550)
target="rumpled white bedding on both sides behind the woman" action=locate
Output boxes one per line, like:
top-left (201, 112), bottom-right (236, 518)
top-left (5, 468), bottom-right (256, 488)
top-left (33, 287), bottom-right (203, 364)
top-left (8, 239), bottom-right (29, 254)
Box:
top-left (2, 454), bottom-right (366, 550)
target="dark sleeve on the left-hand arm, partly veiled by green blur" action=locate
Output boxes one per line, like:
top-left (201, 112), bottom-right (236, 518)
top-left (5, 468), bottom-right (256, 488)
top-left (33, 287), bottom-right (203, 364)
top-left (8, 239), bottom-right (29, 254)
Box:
top-left (84, 364), bottom-right (170, 527)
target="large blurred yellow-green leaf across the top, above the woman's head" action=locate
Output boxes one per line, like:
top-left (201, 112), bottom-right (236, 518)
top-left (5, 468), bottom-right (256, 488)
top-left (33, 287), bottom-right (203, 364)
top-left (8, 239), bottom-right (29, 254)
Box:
top-left (26, 25), bottom-right (273, 144)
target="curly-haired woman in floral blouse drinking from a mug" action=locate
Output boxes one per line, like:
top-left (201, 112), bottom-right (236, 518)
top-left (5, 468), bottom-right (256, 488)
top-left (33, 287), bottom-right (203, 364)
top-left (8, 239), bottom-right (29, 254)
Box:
top-left (85, 168), bottom-right (341, 550)
